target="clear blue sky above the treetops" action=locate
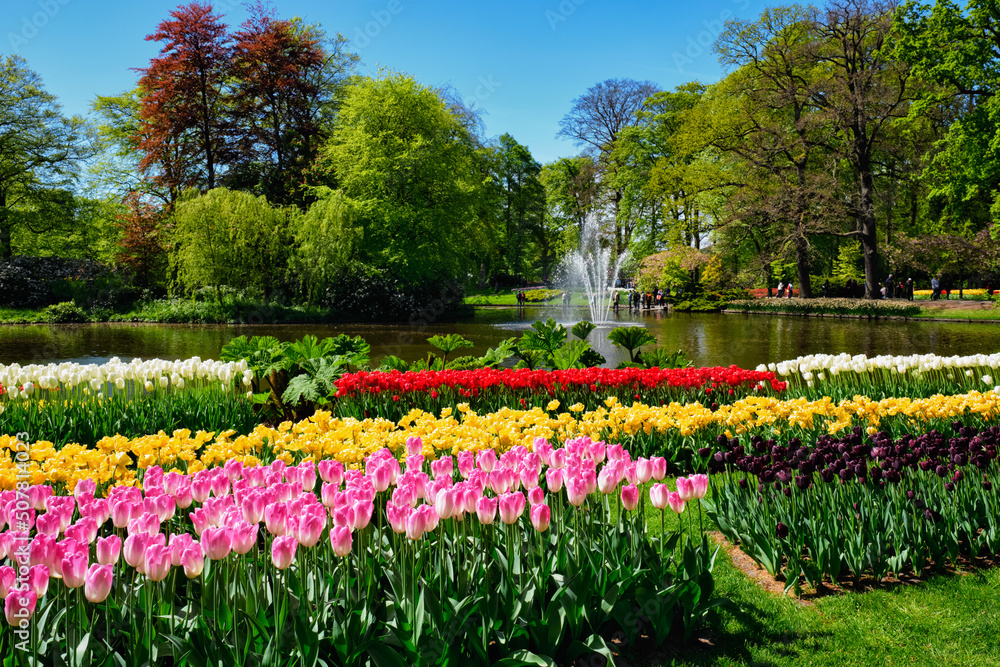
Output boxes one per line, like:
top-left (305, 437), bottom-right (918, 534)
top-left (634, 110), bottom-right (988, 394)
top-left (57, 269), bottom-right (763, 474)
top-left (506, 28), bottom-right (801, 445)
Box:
top-left (0, 0), bottom-right (773, 163)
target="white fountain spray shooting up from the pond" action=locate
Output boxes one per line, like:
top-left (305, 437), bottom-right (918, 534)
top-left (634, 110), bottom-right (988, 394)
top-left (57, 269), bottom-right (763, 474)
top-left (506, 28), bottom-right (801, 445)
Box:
top-left (563, 212), bottom-right (628, 324)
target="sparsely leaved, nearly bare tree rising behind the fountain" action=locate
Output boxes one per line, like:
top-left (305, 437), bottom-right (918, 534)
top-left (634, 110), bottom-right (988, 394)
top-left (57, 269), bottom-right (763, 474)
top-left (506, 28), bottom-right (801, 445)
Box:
top-left (559, 79), bottom-right (658, 255)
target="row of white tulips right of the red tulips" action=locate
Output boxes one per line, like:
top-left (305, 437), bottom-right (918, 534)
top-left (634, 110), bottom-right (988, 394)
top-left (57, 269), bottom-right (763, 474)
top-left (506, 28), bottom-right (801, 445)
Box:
top-left (757, 353), bottom-right (1000, 400)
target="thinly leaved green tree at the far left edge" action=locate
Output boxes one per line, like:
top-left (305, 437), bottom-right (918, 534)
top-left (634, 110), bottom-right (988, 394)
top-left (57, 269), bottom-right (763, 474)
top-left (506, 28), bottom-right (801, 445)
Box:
top-left (0, 56), bottom-right (92, 259)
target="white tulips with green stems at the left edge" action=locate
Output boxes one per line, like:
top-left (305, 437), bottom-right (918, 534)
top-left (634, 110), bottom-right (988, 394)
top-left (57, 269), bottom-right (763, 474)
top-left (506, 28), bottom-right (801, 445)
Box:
top-left (0, 357), bottom-right (257, 446)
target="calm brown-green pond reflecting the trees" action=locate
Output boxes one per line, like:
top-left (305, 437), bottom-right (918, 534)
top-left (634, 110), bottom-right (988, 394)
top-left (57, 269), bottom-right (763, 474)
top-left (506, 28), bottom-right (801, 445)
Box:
top-left (0, 307), bottom-right (1000, 368)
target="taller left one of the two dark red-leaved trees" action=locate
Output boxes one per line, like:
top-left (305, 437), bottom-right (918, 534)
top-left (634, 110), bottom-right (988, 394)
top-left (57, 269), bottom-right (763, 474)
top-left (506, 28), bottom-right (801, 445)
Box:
top-left (137, 2), bottom-right (232, 201)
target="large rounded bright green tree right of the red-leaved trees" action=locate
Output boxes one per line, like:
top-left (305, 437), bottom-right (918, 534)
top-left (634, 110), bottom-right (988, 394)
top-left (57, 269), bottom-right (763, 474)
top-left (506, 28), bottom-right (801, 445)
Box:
top-left (321, 73), bottom-right (491, 288)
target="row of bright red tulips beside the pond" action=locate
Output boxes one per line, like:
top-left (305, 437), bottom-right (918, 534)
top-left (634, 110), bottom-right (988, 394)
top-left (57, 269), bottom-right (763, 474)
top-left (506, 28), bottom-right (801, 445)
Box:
top-left (333, 366), bottom-right (785, 420)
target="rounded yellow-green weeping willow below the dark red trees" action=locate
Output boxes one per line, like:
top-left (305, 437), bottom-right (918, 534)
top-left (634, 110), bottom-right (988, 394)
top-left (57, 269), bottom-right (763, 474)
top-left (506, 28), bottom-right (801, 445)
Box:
top-left (173, 188), bottom-right (289, 302)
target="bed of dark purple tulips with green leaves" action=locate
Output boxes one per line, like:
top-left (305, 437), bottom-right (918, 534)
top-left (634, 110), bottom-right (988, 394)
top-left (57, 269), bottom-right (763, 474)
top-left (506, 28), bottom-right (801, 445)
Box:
top-left (709, 422), bottom-right (1000, 588)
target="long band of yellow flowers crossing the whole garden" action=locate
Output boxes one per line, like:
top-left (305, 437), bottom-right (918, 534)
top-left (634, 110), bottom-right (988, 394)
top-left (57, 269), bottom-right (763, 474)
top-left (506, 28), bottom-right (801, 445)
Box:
top-left (0, 391), bottom-right (1000, 489)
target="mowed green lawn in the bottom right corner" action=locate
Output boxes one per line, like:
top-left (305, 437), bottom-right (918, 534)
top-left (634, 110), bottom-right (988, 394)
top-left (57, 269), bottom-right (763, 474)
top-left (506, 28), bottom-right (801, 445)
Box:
top-left (619, 479), bottom-right (1000, 667)
